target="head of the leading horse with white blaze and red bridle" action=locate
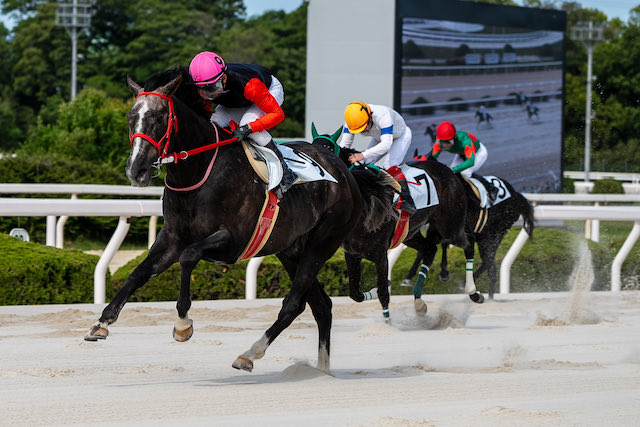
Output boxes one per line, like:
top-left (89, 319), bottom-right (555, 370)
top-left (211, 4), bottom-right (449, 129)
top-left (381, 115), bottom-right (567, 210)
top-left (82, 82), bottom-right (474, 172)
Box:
top-left (125, 74), bottom-right (182, 187)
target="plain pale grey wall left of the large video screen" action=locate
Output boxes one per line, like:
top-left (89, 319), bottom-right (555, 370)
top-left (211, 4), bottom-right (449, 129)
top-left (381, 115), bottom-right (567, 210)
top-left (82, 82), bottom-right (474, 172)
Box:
top-left (305, 0), bottom-right (396, 141)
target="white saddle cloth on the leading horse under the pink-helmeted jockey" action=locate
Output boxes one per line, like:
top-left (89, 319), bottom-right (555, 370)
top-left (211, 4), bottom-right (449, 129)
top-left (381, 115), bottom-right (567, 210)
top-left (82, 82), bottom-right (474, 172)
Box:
top-left (243, 141), bottom-right (338, 190)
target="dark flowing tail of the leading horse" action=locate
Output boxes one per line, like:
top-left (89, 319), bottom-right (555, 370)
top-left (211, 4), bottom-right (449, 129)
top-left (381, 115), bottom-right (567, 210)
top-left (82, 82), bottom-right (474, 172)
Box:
top-left (351, 169), bottom-right (397, 231)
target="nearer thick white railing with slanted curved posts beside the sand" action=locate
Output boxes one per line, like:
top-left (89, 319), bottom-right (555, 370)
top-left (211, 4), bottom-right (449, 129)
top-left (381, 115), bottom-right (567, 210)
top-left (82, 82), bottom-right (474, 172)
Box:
top-left (0, 192), bottom-right (640, 304)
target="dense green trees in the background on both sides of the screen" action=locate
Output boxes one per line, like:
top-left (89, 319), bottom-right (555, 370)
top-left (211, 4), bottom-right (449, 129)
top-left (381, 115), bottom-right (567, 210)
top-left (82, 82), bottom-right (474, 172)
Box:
top-left (0, 0), bottom-right (640, 172)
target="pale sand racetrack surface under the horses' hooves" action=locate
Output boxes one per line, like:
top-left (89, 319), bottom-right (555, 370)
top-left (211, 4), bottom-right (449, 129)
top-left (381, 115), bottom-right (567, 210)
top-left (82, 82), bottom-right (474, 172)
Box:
top-left (0, 292), bottom-right (640, 426)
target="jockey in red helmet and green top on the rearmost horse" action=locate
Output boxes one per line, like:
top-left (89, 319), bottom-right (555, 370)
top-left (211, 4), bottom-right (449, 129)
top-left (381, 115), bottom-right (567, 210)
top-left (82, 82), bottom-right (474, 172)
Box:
top-left (431, 121), bottom-right (498, 203)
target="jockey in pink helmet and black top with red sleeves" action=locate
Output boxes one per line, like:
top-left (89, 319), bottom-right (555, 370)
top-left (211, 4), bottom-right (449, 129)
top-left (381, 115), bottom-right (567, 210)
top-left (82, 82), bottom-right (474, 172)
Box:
top-left (189, 52), bottom-right (297, 197)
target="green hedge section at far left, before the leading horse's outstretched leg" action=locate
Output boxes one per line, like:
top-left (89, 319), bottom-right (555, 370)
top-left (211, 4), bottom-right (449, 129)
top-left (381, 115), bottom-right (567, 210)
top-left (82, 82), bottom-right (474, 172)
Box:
top-left (0, 234), bottom-right (113, 305)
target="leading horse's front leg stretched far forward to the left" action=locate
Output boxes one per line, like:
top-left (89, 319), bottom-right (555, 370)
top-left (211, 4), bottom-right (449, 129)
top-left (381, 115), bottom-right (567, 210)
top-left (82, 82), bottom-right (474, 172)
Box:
top-left (84, 229), bottom-right (181, 341)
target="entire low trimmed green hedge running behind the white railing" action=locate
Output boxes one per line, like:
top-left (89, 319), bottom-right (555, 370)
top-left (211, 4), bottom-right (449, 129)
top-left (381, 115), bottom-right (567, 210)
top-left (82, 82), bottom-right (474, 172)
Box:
top-left (0, 228), bottom-right (640, 305)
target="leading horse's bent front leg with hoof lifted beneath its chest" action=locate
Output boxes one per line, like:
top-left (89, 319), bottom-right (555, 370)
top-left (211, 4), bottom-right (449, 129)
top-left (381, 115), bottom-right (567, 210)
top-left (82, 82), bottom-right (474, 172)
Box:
top-left (173, 229), bottom-right (231, 342)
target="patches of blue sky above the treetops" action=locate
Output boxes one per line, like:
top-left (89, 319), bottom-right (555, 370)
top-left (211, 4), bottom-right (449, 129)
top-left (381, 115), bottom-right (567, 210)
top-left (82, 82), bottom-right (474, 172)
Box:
top-left (0, 0), bottom-right (640, 28)
